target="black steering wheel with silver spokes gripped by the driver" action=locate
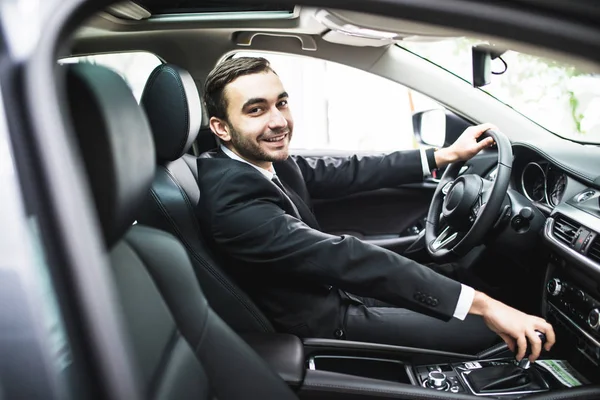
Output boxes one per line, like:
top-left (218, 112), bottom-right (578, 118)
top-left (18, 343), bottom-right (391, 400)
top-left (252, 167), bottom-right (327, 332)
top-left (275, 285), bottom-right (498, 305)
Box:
top-left (425, 129), bottom-right (513, 261)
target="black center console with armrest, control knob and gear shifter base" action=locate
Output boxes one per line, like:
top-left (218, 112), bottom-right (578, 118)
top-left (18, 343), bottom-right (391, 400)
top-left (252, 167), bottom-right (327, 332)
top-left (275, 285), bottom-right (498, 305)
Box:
top-left (245, 334), bottom-right (600, 400)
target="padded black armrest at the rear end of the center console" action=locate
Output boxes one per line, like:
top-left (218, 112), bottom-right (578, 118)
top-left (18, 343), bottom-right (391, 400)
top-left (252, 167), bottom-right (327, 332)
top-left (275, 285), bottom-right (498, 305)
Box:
top-left (242, 333), bottom-right (306, 387)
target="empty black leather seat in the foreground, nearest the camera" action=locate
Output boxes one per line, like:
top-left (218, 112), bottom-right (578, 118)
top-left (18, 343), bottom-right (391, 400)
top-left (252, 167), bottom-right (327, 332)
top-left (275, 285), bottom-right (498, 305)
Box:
top-left (66, 64), bottom-right (296, 400)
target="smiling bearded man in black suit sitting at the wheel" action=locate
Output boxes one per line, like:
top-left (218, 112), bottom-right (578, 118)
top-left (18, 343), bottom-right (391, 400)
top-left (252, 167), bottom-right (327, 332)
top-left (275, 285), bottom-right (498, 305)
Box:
top-left (198, 58), bottom-right (554, 359)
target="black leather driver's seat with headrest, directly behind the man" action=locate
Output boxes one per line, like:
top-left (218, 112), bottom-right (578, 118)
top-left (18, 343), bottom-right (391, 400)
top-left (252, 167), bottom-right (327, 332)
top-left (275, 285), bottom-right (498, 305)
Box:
top-left (137, 64), bottom-right (274, 333)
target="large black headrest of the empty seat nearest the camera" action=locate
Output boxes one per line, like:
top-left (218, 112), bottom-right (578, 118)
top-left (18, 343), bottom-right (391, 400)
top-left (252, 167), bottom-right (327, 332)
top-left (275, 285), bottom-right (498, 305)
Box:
top-left (66, 64), bottom-right (156, 247)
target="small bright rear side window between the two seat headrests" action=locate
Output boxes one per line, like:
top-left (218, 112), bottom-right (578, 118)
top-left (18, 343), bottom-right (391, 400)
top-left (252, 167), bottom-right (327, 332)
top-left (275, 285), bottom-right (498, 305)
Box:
top-left (59, 51), bottom-right (162, 103)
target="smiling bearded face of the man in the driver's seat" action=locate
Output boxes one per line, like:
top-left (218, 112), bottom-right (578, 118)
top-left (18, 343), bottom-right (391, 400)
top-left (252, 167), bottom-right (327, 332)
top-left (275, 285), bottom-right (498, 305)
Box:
top-left (222, 72), bottom-right (294, 165)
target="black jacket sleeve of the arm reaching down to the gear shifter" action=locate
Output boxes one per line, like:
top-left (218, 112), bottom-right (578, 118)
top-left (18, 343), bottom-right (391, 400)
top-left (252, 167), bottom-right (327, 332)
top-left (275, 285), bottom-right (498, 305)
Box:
top-left (209, 169), bottom-right (461, 320)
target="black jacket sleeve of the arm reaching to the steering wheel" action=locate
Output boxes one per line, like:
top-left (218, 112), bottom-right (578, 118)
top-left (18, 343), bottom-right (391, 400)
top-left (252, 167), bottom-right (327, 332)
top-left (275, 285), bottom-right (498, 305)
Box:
top-left (294, 150), bottom-right (423, 199)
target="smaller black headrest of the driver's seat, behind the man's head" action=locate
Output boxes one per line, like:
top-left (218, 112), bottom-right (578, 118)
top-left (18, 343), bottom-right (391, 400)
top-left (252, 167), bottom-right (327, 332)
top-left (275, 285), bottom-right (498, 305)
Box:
top-left (141, 64), bottom-right (202, 161)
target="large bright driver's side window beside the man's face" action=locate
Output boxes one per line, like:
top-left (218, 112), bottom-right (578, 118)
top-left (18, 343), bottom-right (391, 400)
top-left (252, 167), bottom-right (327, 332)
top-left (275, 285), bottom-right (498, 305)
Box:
top-left (234, 51), bottom-right (442, 152)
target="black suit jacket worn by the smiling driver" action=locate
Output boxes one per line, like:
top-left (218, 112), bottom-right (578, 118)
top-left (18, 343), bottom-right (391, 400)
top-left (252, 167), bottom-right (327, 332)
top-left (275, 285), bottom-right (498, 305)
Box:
top-left (198, 151), bottom-right (460, 337)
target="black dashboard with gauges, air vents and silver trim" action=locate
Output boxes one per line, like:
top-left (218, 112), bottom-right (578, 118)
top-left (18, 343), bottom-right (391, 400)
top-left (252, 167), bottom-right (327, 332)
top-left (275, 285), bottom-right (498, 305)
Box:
top-left (510, 146), bottom-right (600, 370)
